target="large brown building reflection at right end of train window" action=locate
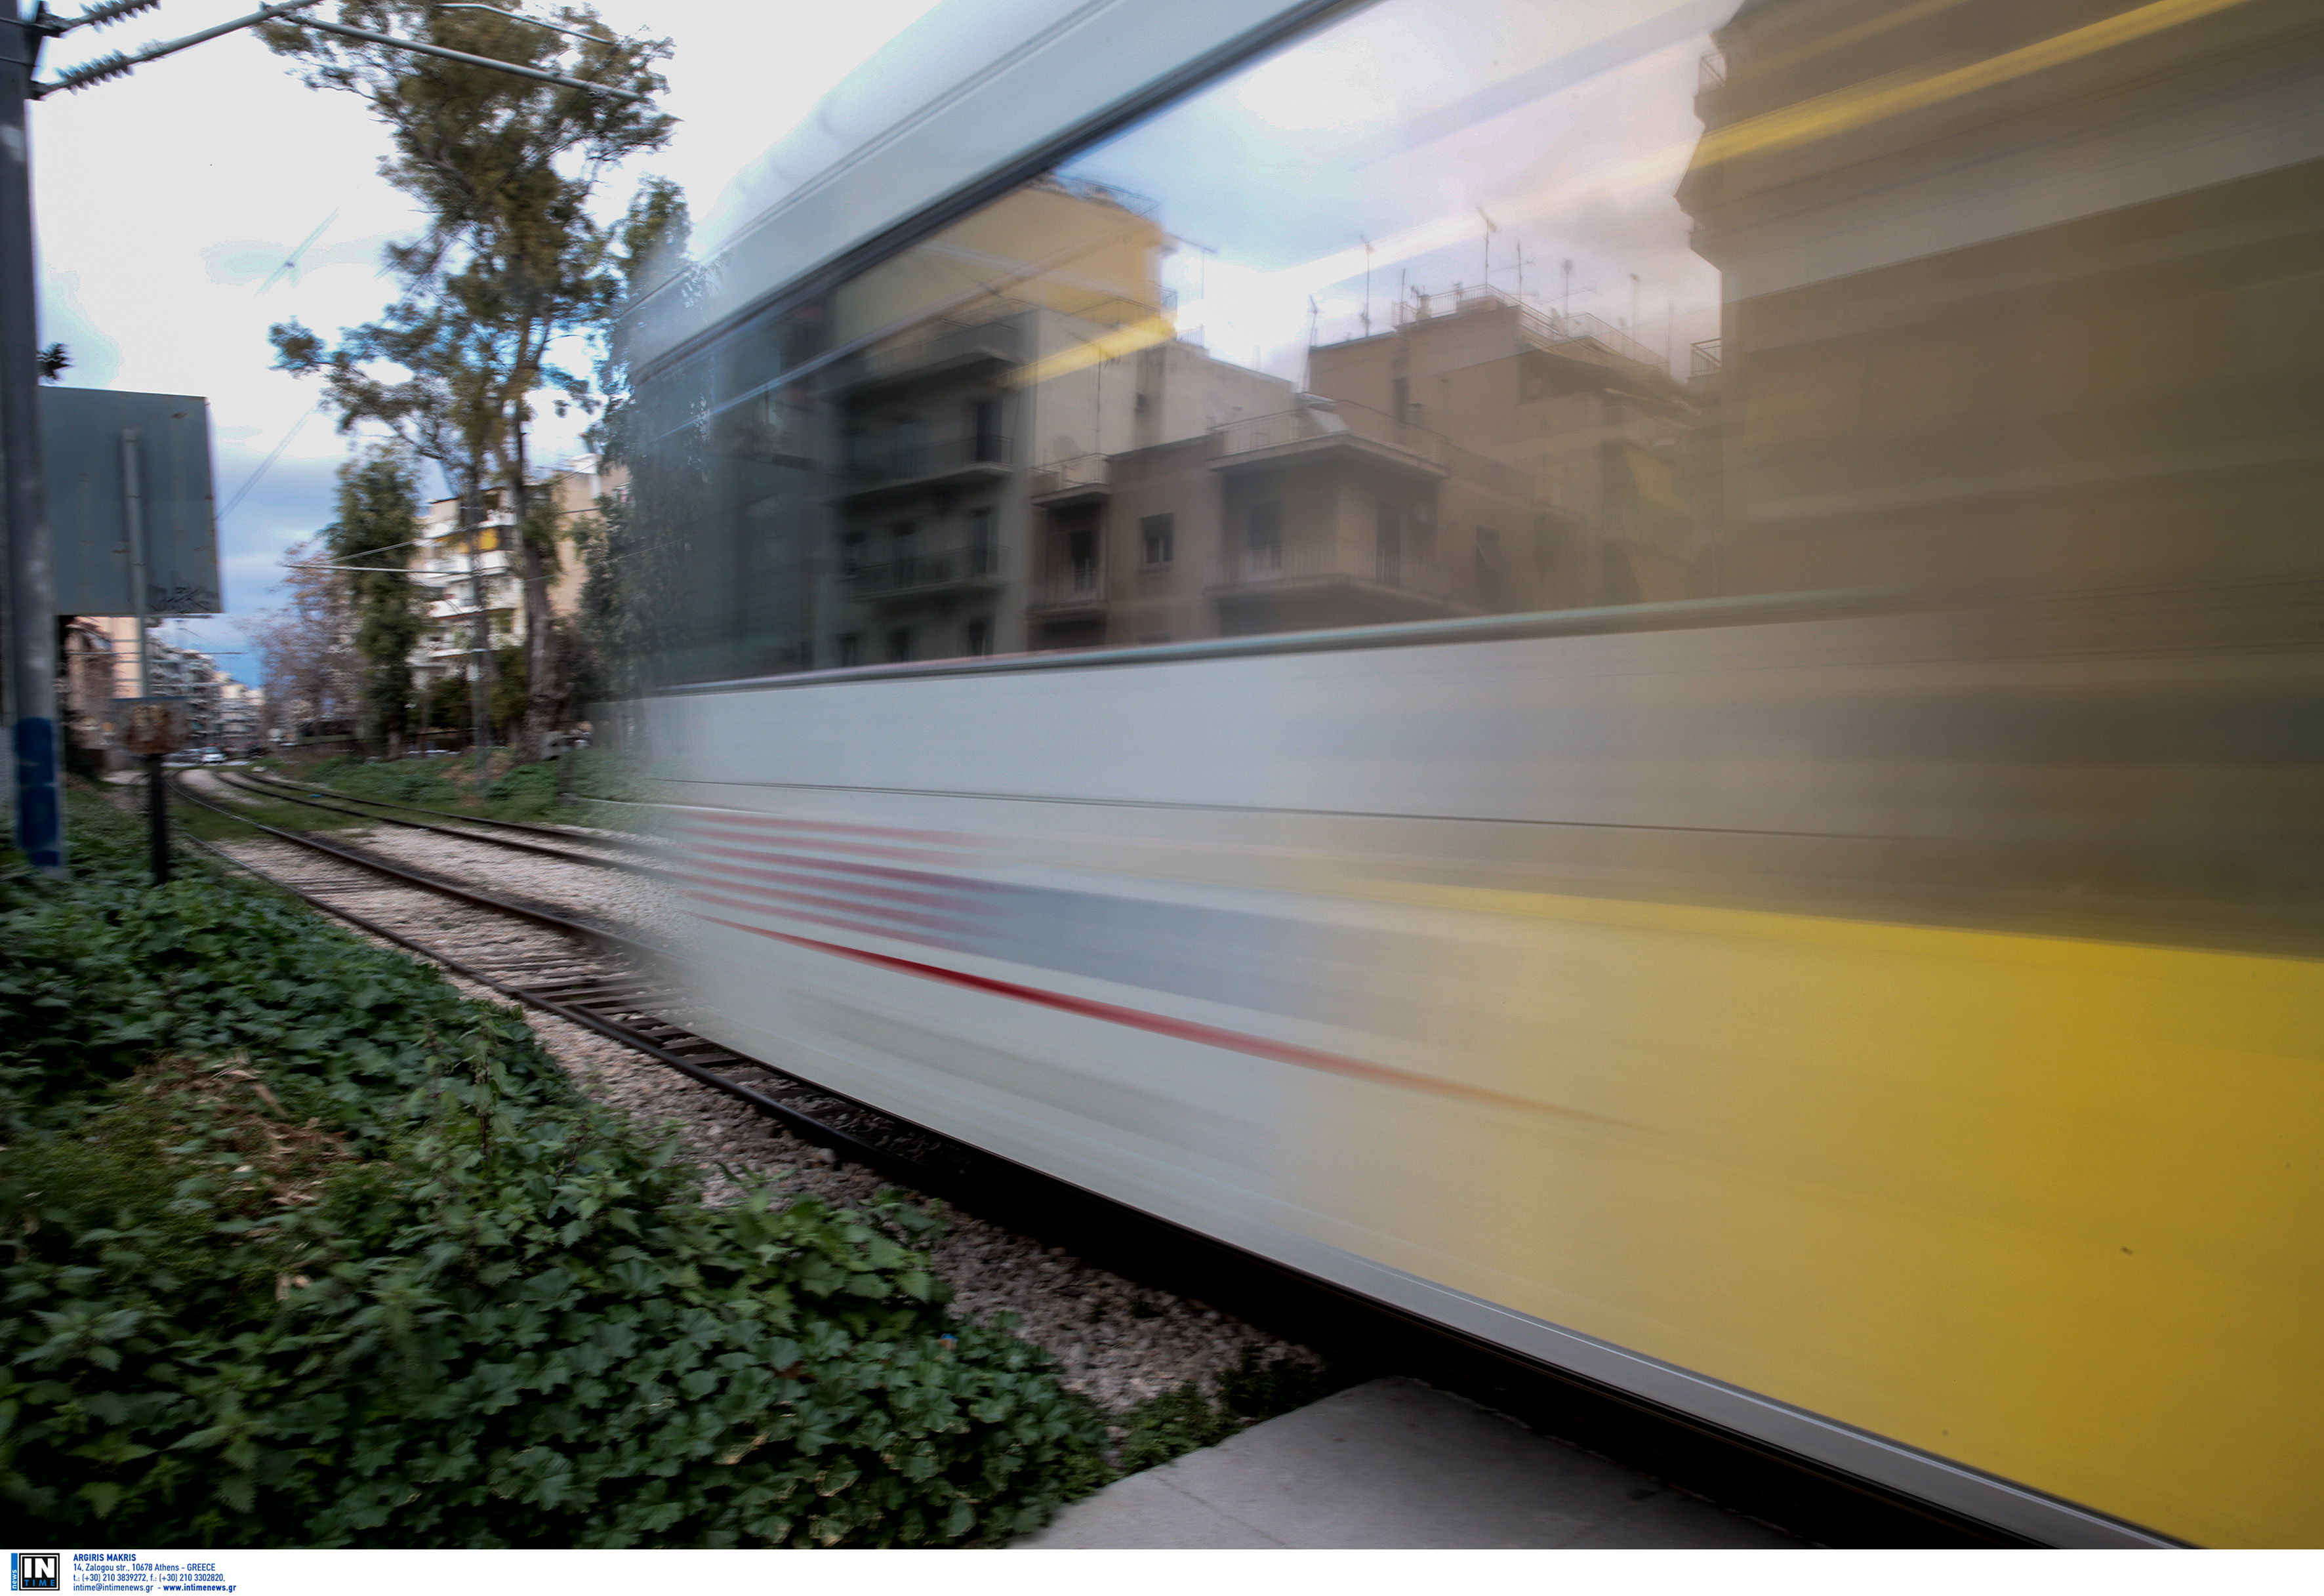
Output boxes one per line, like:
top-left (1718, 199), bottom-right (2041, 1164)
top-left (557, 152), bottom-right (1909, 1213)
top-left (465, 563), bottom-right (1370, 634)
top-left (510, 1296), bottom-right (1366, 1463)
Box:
top-left (1681, 0), bottom-right (2324, 592)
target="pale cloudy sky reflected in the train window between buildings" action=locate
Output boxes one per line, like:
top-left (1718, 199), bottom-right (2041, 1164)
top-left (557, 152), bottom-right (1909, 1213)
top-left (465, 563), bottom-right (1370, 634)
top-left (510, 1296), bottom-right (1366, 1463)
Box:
top-left (1067, 0), bottom-right (1729, 381)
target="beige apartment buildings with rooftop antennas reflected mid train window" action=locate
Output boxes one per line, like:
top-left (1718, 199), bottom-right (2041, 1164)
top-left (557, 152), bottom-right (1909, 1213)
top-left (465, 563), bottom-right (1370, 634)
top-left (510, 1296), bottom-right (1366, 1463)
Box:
top-left (1027, 293), bottom-right (1711, 648)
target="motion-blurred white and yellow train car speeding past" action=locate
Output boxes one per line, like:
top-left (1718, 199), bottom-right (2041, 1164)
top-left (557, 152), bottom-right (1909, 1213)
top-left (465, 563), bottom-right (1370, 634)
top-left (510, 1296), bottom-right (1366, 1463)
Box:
top-left (611, 0), bottom-right (2324, 1545)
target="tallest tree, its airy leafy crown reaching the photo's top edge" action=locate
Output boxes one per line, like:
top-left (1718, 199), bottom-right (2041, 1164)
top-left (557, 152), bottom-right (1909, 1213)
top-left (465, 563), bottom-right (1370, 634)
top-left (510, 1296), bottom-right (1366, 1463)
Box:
top-left (260, 0), bottom-right (676, 758)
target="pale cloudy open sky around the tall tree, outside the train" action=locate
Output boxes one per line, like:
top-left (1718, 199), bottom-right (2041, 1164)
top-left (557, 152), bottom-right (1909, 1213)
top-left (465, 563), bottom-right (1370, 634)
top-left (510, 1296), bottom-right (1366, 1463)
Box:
top-left (30, 0), bottom-right (932, 681)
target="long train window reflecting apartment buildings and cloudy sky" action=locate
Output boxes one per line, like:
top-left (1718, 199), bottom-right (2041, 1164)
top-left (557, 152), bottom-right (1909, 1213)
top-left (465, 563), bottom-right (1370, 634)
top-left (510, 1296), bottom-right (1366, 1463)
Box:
top-left (613, 0), bottom-right (2317, 681)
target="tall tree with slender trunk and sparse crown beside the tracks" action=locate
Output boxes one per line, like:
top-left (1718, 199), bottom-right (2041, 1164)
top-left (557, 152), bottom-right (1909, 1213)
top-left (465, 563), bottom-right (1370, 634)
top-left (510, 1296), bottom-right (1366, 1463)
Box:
top-left (262, 0), bottom-right (674, 758)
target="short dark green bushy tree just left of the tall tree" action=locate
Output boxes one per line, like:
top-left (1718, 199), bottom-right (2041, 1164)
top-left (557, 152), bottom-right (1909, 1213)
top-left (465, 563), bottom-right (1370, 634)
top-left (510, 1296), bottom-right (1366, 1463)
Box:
top-left (325, 449), bottom-right (425, 752)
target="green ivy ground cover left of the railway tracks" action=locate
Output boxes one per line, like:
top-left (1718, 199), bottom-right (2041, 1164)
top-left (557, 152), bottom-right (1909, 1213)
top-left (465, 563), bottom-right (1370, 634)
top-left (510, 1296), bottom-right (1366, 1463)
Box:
top-left (0, 802), bottom-right (1109, 1547)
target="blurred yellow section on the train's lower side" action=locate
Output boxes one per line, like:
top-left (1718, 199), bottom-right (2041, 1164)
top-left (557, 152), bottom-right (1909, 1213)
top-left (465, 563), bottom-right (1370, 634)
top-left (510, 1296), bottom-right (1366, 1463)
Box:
top-left (1297, 880), bottom-right (2324, 1545)
